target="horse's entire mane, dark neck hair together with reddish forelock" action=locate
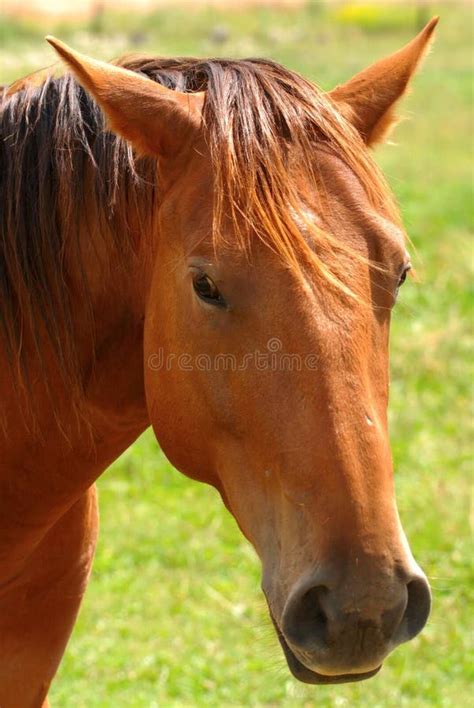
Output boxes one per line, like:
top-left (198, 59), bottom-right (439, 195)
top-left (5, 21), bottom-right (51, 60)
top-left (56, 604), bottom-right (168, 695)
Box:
top-left (0, 56), bottom-right (397, 406)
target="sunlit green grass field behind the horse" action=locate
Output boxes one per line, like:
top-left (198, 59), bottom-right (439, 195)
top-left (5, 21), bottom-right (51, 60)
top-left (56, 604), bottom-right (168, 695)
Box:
top-left (0, 3), bottom-right (473, 708)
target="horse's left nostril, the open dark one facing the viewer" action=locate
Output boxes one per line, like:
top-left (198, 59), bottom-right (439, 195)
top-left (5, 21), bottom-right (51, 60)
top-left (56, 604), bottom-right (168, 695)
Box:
top-left (283, 585), bottom-right (328, 650)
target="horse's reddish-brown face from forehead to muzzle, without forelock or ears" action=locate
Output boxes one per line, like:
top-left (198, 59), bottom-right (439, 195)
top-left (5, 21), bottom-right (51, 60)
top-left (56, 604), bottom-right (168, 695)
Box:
top-left (145, 147), bottom-right (430, 683)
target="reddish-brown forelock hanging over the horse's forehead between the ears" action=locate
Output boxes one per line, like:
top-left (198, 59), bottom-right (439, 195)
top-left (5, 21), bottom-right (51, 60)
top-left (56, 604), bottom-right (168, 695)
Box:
top-left (118, 56), bottom-right (400, 299)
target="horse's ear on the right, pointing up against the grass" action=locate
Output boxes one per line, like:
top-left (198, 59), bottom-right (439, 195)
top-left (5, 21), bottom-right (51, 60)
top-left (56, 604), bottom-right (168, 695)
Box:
top-left (329, 17), bottom-right (439, 145)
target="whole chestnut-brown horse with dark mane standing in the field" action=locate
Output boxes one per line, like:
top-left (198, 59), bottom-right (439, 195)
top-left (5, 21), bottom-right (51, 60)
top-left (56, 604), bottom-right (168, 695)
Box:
top-left (0, 19), bottom-right (436, 708)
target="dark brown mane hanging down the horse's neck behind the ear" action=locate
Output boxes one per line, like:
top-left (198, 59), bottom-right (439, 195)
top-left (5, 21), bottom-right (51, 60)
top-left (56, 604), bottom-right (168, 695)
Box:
top-left (0, 67), bottom-right (154, 404)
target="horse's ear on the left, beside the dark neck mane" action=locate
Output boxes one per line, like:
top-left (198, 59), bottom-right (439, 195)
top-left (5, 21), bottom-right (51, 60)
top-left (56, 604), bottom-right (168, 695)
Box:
top-left (46, 37), bottom-right (205, 157)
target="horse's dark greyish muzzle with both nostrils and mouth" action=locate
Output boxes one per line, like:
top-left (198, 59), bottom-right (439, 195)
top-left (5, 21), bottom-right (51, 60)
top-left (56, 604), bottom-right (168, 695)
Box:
top-left (264, 567), bottom-right (431, 683)
